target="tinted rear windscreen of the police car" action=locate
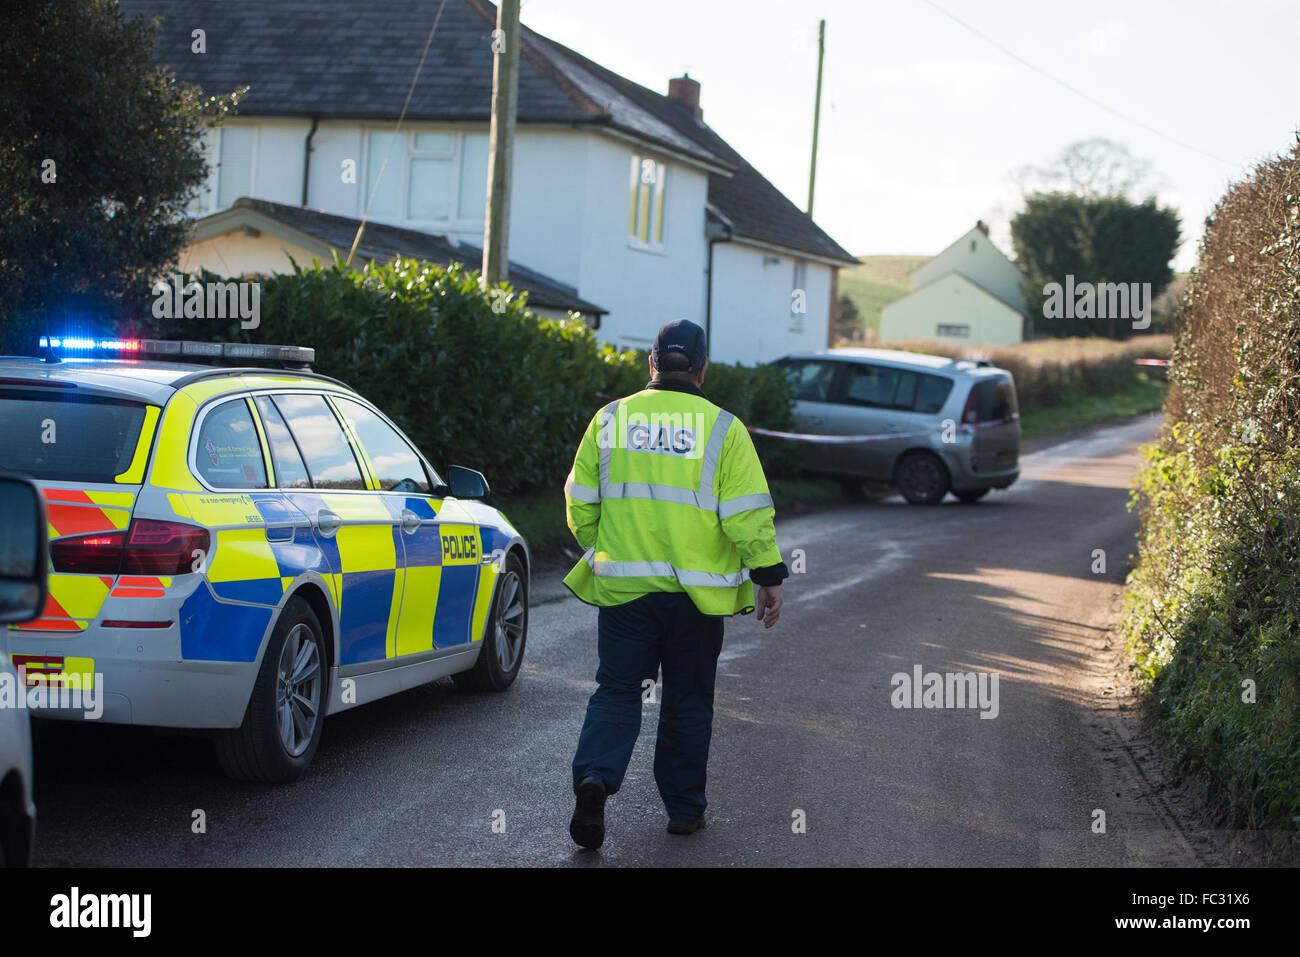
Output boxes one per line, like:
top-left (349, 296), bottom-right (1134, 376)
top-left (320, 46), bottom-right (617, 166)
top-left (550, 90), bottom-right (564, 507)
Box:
top-left (0, 390), bottom-right (144, 484)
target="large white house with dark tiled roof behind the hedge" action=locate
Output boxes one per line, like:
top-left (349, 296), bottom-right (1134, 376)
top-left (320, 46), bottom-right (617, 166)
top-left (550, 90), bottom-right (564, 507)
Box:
top-left (121, 0), bottom-right (855, 363)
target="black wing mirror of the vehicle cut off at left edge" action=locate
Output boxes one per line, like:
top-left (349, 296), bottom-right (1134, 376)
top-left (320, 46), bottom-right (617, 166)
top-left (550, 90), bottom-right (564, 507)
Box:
top-left (0, 476), bottom-right (48, 624)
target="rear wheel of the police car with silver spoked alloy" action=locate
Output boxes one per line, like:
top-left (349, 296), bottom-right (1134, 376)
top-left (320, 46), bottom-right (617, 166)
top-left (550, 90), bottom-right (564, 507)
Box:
top-left (215, 598), bottom-right (329, 784)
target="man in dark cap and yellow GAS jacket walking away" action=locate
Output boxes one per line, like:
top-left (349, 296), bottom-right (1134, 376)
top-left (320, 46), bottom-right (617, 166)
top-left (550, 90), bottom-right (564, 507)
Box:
top-left (564, 319), bottom-right (788, 848)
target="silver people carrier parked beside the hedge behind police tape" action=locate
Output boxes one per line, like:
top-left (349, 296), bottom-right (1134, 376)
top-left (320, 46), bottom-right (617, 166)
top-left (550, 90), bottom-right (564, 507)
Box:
top-left (776, 348), bottom-right (1021, 505)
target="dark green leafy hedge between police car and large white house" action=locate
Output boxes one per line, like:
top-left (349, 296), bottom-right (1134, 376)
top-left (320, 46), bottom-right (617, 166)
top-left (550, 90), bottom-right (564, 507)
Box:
top-left (166, 260), bottom-right (797, 495)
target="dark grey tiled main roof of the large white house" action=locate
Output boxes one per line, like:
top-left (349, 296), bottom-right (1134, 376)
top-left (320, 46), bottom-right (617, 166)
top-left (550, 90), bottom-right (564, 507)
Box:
top-left (121, 0), bottom-right (855, 263)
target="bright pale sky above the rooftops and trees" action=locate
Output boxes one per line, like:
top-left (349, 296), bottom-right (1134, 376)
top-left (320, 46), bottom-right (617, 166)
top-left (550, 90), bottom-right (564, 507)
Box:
top-left (521, 0), bottom-right (1300, 269)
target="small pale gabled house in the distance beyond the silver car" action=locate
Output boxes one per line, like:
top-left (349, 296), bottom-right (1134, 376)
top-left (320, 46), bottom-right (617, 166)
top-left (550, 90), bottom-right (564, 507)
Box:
top-left (880, 222), bottom-right (1032, 346)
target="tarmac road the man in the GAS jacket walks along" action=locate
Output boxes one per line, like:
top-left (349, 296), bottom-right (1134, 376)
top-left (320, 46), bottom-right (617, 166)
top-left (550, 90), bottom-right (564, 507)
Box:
top-left (35, 417), bottom-right (1214, 866)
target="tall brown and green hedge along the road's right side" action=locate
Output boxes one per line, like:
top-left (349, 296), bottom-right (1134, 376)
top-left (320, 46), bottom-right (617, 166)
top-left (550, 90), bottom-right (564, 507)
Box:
top-left (1125, 134), bottom-right (1300, 828)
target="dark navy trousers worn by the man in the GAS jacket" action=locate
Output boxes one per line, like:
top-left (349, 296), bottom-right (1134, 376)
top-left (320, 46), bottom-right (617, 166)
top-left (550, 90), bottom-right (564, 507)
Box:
top-left (573, 592), bottom-right (723, 820)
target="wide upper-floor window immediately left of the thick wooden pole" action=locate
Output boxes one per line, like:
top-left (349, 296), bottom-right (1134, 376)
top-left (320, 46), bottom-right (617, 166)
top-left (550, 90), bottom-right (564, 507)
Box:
top-left (361, 130), bottom-right (488, 222)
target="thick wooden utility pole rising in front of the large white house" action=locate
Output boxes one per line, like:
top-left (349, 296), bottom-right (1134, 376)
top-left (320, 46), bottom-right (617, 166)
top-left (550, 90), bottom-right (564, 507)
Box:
top-left (482, 0), bottom-right (519, 286)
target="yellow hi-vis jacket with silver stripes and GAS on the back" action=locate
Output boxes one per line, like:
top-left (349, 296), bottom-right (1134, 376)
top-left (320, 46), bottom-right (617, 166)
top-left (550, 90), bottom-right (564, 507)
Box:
top-left (564, 381), bottom-right (784, 615)
